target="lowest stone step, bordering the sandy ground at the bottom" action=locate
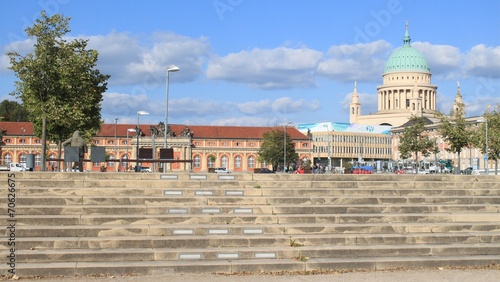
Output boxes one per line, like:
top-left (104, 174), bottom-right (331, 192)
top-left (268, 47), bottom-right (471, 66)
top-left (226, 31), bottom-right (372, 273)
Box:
top-left (0, 255), bottom-right (500, 278)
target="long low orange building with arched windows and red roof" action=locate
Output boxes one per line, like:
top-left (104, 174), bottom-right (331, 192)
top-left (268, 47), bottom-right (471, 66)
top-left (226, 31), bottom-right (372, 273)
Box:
top-left (0, 122), bottom-right (311, 172)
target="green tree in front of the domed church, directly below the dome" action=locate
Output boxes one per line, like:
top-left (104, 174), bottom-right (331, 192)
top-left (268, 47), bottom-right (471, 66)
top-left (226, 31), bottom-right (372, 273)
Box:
top-left (398, 116), bottom-right (436, 167)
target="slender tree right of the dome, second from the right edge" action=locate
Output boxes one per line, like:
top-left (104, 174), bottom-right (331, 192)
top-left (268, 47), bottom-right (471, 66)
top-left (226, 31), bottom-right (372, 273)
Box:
top-left (437, 103), bottom-right (472, 174)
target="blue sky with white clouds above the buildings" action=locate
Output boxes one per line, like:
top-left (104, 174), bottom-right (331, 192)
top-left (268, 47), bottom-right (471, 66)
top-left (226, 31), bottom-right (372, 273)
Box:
top-left (0, 0), bottom-right (500, 126)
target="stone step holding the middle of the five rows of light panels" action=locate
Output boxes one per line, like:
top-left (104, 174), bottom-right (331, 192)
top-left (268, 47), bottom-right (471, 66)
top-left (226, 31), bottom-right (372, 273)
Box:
top-left (7, 201), bottom-right (500, 217)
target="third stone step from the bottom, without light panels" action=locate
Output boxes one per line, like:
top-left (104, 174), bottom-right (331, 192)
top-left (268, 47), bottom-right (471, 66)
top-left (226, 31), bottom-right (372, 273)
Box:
top-left (4, 231), bottom-right (500, 250)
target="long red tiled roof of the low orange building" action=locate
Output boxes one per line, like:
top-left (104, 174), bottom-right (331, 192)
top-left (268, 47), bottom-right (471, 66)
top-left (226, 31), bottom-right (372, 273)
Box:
top-left (0, 122), bottom-right (308, 140)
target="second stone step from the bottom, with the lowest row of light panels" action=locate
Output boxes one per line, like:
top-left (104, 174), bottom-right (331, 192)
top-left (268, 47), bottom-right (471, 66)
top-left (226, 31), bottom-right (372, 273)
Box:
top-left (10, 244), bottom-right (500, 263)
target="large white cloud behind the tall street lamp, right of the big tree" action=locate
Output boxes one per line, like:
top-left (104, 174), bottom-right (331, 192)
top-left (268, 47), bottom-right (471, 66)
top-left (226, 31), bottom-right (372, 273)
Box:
top-left (89, 32), bottom-right (210, 86)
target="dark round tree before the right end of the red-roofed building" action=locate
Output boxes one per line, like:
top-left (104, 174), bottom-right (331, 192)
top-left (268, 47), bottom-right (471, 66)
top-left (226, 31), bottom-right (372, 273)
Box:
top-left (259, 130), bottom-right (299, 169)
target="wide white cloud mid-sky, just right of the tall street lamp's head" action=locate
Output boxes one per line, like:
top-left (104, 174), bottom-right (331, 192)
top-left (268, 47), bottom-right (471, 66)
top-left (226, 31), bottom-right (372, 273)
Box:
top-left (207, 47), bottom-right (322, 89)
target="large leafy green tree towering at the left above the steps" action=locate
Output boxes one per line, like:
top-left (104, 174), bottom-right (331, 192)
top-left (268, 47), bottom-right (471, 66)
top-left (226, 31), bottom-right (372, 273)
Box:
top-left (7, 11), bottom-right (109, 170)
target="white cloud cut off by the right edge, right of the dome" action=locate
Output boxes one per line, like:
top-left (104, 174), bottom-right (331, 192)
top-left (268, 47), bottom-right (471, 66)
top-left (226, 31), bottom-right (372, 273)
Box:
top-left (464, 44), bottom-right (500, 78)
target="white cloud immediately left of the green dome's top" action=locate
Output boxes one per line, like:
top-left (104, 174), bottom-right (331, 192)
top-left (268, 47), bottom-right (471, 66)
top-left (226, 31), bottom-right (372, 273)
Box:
top-left (318, 40), bottom-right (391, 82)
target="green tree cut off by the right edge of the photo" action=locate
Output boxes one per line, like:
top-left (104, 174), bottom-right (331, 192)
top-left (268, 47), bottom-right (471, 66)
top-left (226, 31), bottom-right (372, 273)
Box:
top-left (472, 104), bottom-right (500, 175)
